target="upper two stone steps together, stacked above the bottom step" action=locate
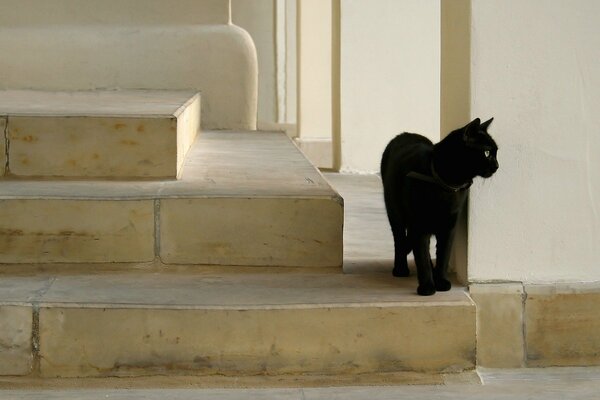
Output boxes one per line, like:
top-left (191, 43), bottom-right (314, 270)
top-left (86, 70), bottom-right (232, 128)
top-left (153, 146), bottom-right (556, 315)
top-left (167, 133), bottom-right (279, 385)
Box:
top-left (0, 91), bottom-right (343, 267)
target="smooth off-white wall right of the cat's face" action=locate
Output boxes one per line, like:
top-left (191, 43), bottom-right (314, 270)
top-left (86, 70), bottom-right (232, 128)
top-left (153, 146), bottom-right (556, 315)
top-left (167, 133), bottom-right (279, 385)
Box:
top-left (469, 0), bottom-right (600, 282)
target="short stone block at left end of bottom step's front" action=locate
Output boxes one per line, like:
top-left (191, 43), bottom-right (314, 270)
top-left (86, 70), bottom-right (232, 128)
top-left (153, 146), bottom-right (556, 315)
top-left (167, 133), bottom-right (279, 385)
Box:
top-left (0, 305), bottom-right (33, 375)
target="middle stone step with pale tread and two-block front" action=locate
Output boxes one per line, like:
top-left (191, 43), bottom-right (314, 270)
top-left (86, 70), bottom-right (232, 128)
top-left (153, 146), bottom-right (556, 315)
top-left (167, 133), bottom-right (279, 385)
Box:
top-left (0, 131), bottom-right (344, 268)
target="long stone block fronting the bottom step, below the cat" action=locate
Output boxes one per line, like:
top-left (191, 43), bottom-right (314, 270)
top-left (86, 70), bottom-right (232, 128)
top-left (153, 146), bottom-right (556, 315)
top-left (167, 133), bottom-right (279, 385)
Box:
top-left (40, 304), bottom-right (475, 377)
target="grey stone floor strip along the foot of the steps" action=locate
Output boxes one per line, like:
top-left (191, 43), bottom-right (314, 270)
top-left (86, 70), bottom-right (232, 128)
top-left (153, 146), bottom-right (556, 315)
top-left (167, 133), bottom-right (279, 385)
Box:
top-left (0, 367), bottom-right (600, 400)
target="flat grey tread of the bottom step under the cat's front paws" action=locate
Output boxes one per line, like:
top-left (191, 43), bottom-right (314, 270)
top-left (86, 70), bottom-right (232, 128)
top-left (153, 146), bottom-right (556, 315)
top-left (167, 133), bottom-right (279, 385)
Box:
top-left (0, 267), bottom-right (473, 309)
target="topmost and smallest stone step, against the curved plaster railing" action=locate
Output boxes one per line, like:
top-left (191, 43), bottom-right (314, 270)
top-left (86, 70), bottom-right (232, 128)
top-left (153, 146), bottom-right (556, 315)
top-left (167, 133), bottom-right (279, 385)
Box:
top-left (0, 90), bottom-right (200, 179)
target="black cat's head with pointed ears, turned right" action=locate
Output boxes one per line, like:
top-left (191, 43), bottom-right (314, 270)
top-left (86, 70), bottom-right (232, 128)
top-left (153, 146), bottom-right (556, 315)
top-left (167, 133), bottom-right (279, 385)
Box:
top-left (455, 118), bottom-right (498, 178)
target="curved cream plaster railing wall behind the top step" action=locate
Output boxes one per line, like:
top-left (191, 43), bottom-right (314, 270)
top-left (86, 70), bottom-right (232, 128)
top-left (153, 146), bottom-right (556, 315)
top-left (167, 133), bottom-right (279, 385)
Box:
top-left (0, 0), bottom-right (258, 129)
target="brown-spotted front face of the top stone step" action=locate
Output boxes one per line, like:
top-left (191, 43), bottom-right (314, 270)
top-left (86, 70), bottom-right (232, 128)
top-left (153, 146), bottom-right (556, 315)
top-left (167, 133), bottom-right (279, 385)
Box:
top-left (8, 117), bottom-right (177, 178)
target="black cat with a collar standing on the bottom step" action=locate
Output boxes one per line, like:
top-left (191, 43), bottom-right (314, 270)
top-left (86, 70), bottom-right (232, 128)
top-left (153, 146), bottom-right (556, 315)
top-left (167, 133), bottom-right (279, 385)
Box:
top-left (381, 118), bottom-right (498, 296)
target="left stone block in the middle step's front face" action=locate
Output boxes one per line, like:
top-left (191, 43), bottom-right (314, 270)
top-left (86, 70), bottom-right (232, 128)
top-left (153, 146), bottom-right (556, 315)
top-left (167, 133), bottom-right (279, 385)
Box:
top-left (0, 199), bottom-right (154, 263)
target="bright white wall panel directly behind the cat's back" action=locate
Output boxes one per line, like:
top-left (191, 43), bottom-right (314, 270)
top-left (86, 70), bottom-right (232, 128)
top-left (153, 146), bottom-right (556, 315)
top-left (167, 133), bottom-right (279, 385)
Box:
top-left (340, 0), bottom-right (440, 172)
